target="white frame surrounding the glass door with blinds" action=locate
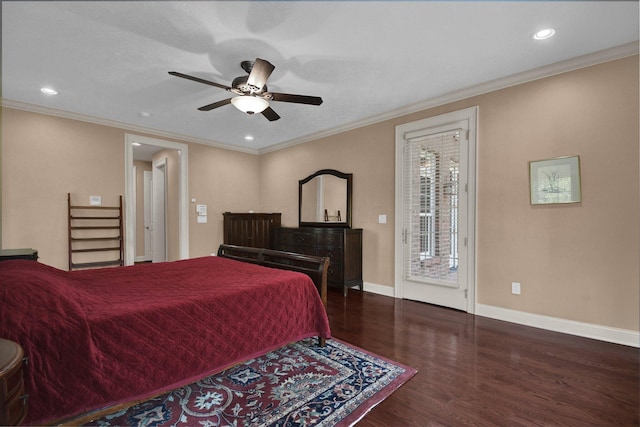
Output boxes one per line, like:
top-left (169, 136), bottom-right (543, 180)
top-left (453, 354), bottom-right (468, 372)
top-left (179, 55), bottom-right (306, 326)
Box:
top-left (394, 106), bottom-right (478, 314)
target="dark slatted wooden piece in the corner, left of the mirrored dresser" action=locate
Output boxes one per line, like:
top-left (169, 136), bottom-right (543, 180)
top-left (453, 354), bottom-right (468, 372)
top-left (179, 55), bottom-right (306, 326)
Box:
top-left (223, 212), bottom-right (282, 249)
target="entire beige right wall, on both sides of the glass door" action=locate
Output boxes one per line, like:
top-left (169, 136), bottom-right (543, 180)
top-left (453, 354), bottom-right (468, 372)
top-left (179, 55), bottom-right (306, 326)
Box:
top-left (260, 56), bottom-right (640, 330)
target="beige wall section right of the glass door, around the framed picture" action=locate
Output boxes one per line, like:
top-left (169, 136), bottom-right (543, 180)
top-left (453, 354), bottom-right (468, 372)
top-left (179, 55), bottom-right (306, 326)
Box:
top-left (478, 56), bottom-right (640, 330)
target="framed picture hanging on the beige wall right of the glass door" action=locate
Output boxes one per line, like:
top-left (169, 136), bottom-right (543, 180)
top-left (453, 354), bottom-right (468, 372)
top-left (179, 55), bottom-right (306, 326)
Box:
top-left (529, 156), bottom-right (582, 205)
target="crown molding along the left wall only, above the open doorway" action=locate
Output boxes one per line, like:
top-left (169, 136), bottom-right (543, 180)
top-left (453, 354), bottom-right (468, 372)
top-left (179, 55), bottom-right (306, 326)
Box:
top-left (0, 98), bottom-right (259, 155)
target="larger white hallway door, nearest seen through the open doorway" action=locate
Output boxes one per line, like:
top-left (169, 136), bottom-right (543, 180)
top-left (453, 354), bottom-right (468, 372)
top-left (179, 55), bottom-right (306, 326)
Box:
top-left (151, 158), bottom-right (167, 262)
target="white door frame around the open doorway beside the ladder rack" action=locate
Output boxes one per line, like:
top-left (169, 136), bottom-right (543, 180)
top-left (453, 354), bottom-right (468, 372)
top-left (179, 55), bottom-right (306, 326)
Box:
top-left (124, 133), bottom-right (189, 265)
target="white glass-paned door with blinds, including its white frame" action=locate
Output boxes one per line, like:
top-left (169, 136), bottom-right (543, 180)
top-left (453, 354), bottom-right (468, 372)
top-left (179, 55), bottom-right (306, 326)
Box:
top-left (396, 108), bottom-right (476, 312)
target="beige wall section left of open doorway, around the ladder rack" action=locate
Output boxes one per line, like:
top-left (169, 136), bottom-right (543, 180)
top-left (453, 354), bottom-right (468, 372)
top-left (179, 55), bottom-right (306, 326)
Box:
top-left (2, 109), bottom-right (124, 269)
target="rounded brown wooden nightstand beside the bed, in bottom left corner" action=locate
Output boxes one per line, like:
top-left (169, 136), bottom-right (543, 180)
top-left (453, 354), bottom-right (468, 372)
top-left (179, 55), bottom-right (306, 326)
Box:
top-left (0, 338), bottom-right (28, 426)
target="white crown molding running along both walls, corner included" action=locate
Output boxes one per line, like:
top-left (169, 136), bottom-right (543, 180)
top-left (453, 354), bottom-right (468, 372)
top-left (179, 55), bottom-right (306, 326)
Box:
top-left (1, 41), bottom-right (640, 155)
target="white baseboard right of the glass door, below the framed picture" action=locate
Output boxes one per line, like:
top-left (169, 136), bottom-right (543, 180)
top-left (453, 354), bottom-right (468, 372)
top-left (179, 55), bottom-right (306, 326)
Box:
top-left (476, 304), bottom-right (640, 347)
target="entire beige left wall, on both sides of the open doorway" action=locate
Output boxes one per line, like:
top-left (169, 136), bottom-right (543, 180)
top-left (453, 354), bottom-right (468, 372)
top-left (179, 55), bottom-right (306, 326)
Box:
top-left (1, 108), bottom-right (260, 269)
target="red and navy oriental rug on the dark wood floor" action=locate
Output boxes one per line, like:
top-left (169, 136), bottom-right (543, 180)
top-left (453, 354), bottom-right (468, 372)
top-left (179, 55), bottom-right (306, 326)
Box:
top-left (87, 339), bottom-right (416, 427)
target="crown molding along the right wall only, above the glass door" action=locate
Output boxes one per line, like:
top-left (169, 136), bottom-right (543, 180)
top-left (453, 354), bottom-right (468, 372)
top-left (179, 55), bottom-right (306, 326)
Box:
top-left (258, 41), bottom-right (640, 154)
